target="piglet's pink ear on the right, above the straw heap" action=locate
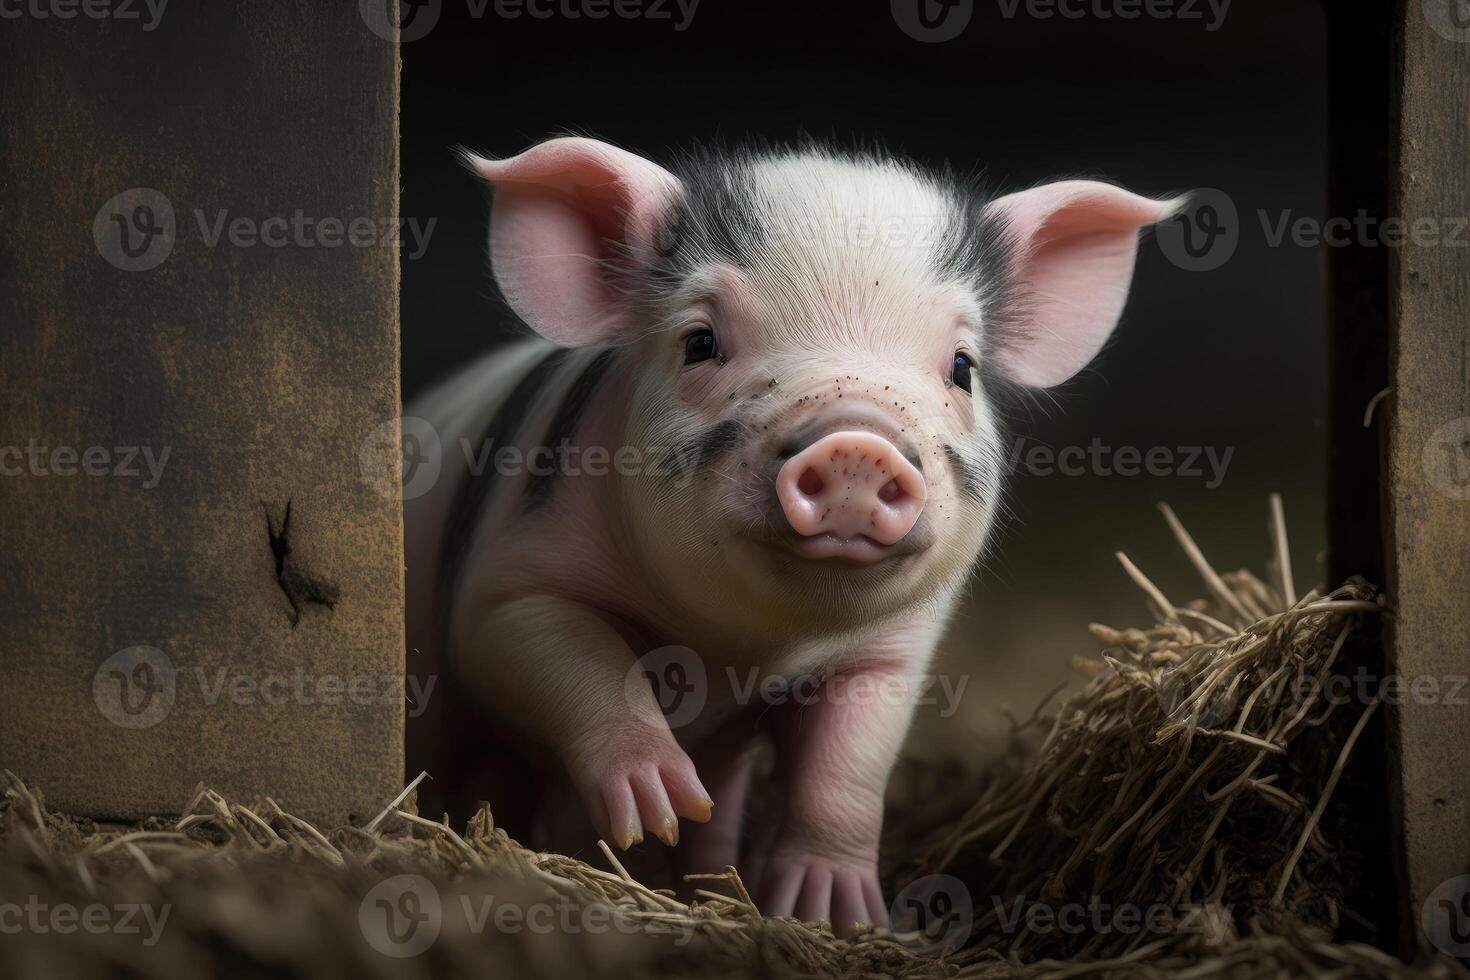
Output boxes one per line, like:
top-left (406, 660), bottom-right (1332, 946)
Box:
top-left (986, 181), bottom-right (1185, 388)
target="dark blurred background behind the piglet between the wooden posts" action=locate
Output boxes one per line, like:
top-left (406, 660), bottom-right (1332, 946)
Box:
top-left (403, 0), bottom-right (1327, 751)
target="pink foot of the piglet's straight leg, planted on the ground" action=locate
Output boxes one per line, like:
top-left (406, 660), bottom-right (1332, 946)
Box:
top-left (760, 854), bottom-right (888, 937)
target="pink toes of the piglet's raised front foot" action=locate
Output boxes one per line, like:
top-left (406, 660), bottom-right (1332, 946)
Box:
top-left (587, 745), bottom-right (714, 851)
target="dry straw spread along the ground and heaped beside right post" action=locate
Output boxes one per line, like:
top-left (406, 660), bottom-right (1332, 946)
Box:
top-left (0, 501), bottom-right (1470, 977)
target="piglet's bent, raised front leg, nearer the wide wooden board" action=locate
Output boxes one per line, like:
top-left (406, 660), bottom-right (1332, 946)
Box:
top-left (454, 597), bottom-right (711, 849)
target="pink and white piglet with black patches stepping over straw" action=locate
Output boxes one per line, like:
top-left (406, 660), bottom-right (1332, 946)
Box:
top-left (406, 138), bottom-right (1180, 933)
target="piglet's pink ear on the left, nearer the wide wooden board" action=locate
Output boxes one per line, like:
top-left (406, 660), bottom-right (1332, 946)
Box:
top-left (465, 137), bottom-right (679, 347)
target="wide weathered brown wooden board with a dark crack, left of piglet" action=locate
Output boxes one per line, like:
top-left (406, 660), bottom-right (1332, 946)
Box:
top-left (0, 1), bottom-right (404, 821)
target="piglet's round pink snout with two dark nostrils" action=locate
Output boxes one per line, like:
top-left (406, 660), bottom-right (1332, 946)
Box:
top-left (776, 432), bottom-right (926, 545)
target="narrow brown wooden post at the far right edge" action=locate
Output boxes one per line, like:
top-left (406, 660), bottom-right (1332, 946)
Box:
top-left (1386, 0), bottom-right (1470, 952)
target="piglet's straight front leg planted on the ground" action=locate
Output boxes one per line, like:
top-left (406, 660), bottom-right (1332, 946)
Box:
top-left (760, 629), bottom-right (936, 936)
